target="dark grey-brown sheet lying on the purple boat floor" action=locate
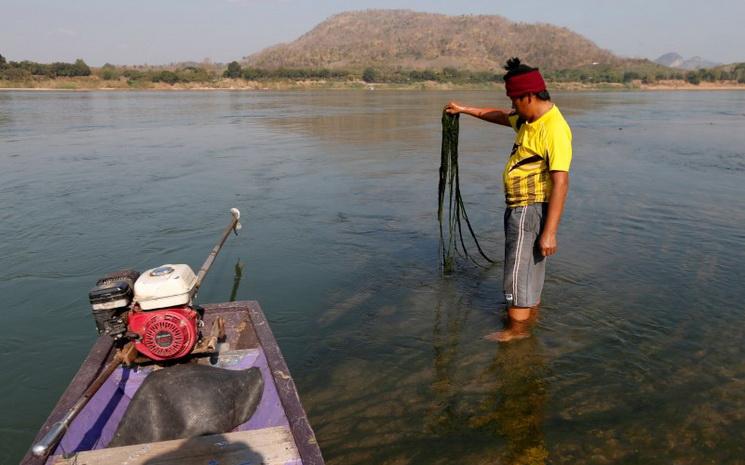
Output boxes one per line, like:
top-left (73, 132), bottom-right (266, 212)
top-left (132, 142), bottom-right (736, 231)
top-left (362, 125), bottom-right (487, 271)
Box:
top-left (109, 364), bottom-right (264, 447)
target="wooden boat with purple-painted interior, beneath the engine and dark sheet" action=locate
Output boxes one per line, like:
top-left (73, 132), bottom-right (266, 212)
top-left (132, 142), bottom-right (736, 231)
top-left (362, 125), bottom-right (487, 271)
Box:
top-left (21, 301), bottom-right (324, 465)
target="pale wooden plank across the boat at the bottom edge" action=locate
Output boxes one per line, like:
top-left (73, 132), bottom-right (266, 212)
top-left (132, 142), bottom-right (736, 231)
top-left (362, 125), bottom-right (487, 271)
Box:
top-left (55, 426), bottom-right (299, 465)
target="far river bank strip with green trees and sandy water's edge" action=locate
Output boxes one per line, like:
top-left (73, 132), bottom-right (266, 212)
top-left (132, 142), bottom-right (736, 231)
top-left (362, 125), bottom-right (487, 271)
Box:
top-left (0, 55), bottom-right (745, 91)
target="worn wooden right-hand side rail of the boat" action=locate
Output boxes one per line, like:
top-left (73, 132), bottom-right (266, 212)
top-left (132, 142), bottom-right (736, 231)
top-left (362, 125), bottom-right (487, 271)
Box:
top-left (247, 300), bottom-right (325, 465)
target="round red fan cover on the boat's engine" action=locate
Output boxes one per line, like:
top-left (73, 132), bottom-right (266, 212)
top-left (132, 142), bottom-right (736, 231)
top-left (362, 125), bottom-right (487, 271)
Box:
top-left (127, 307), bottom-right (199, 360)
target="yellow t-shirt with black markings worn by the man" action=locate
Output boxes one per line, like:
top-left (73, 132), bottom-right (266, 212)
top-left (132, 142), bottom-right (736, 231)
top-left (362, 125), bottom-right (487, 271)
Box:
top-left (502, 105), bottom-right (572, 207)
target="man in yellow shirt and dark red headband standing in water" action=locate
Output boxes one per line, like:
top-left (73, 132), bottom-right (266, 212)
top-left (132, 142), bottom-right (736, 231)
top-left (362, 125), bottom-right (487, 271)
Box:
top-left (445, 58), bottom-right (572, 342)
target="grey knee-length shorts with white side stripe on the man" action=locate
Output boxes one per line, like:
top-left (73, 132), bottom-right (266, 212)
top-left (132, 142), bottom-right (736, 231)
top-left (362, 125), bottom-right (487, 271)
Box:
top-left (503, 203), bottom-right (548, 307)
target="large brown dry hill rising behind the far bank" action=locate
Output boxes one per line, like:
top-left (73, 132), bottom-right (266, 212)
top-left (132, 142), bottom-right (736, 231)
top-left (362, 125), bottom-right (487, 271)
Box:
top-left (244, 10), bottom-right (624, 71)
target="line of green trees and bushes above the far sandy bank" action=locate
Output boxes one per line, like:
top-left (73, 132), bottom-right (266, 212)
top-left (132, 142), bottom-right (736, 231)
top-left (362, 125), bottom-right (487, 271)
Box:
top-left (0, 55), bottom-right (745, 87)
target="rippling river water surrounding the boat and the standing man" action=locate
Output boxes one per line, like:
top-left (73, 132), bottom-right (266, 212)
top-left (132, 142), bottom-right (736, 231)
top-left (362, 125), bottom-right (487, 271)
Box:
top-left (0, 91), bottom-right (745, 465)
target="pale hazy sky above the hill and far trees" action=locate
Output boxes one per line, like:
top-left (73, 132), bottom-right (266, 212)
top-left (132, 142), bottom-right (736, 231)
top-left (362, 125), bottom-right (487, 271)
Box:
top-left (0, 0), bottom-right (745, 66)
